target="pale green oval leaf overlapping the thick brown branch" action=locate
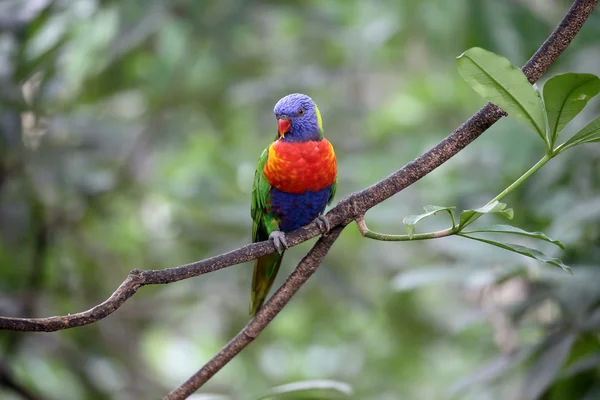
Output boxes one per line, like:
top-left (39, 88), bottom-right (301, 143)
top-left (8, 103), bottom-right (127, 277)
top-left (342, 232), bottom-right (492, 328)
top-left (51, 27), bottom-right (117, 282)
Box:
top-left (457, 47), bottom-right (547, 143)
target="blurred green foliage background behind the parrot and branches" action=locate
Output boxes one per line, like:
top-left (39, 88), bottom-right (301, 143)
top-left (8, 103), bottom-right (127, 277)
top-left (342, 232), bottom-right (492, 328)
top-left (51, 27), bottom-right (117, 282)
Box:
top-left (0, 0), bottom-right (600, 400)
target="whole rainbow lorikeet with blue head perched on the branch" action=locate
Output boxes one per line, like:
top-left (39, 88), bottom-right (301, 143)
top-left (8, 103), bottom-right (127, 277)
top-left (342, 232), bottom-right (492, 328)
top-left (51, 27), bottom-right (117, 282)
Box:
top-left (250, 93), bottom-right (337, 316)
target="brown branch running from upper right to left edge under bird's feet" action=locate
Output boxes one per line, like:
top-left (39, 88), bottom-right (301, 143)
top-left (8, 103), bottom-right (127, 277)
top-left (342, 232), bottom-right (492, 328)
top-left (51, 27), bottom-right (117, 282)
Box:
top-left (0, 0), bottom-right (598, 344)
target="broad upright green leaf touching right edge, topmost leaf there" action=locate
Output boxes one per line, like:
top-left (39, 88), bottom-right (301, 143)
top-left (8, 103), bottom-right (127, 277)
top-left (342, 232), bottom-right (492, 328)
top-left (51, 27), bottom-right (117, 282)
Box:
top-left (544, 73), bottom-right (600, 144)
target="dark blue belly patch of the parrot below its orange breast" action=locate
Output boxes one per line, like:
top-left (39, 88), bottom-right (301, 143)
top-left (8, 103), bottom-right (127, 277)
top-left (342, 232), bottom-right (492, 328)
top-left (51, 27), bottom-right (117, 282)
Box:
top-left (270, 186), bottom-right (331, 232)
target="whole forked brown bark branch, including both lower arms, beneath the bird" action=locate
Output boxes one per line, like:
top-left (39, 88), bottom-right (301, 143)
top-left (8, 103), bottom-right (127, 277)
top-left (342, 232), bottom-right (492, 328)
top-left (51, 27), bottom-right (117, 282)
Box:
top-left (0, 0), bottom-right (598, 399)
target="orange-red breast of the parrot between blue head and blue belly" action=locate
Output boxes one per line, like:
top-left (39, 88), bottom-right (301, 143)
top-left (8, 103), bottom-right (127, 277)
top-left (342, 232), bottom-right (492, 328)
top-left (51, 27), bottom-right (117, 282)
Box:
top-left (263, 139), bottom-right (337, 193)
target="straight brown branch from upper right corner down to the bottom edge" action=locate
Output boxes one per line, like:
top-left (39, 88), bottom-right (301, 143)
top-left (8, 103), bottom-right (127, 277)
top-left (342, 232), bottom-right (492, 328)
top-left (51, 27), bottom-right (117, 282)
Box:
top-left (164, 0), bottom-right (598, 400)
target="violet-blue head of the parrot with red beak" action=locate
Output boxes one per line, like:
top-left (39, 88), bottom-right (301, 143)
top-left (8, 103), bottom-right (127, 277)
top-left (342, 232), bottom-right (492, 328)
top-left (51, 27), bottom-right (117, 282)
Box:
top-left (273, 93), bottom-right (323, 142)
